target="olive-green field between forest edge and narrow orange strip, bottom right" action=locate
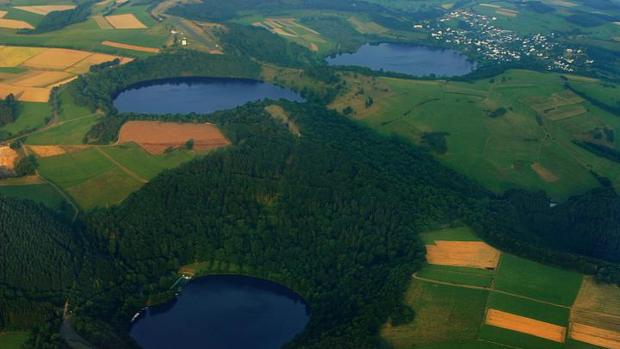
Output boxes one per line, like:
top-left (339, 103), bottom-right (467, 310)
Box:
top-left (381, 280), bottom-right (488, 349)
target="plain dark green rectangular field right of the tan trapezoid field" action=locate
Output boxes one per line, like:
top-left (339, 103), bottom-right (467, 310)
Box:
top-left (495, 253), bottom-right (582, 306)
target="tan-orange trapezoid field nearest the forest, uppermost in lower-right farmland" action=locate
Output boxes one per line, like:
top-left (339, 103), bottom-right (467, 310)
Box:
top-left (426, 241), bottom-right (500, 269)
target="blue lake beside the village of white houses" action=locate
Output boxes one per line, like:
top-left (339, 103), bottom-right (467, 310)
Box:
top-left (327, 43), bottom-right (476, 77)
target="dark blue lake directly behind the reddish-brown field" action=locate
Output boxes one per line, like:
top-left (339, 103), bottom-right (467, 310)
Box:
top-left (114, 78), bottom-right (303, 114)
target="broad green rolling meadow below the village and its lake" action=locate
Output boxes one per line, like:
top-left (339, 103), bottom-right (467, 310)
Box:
top-left (331, 70), bottom-right (620, 200)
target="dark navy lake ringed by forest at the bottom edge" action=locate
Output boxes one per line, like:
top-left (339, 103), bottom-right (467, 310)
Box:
top-left (130, 275), bottom-right (309, 349)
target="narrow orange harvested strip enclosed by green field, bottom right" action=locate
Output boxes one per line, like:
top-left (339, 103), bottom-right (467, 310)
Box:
top-left (485, 309), bottom-right (566, 343)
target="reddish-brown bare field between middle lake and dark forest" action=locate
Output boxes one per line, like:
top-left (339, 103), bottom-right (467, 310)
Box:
top-left (118, 121), bottom-right (230, 154)
